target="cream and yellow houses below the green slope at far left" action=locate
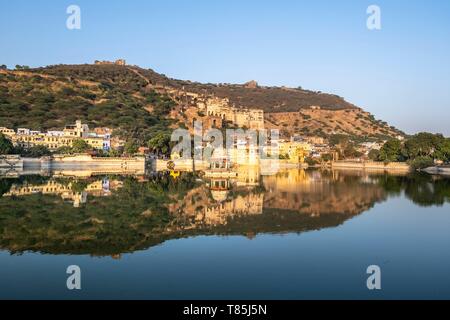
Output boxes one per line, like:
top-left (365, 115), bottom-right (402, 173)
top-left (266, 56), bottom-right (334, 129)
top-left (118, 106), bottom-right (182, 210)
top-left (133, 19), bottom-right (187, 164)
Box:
top-left (0, 120), bottom-right (112, 151)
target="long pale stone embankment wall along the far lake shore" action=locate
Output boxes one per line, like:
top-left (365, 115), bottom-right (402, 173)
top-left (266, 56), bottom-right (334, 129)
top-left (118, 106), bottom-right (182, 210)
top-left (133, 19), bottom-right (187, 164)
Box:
top-left (0, 154), bottom-right (450, 177)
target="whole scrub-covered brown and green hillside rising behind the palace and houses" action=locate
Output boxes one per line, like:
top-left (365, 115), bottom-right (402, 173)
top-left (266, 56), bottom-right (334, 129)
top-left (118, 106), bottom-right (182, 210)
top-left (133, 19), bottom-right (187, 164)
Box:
top-left (0, 64), bottom-right (402, 142)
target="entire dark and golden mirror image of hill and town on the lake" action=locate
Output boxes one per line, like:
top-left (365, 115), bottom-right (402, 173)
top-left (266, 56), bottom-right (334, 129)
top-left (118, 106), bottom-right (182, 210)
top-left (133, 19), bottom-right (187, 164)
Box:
top-left (0, 169), bottom-right (450, 256)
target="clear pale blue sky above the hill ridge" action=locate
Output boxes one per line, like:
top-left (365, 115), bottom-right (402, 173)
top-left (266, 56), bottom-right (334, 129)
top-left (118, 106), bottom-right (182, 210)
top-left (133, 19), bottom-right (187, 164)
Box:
top-left (0, 0), bottom-right (450, 136)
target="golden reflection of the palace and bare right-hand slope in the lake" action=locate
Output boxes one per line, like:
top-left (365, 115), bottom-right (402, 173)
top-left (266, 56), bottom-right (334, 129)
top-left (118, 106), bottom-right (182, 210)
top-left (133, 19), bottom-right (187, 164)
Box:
top-left (169, 167), bottom-right (386, 229)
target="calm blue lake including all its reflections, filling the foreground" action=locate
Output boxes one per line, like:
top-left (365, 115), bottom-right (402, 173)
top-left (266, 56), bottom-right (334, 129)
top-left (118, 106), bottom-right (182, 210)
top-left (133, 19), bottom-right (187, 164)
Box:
top-left (0, 170), bottom-right (450, 299)
